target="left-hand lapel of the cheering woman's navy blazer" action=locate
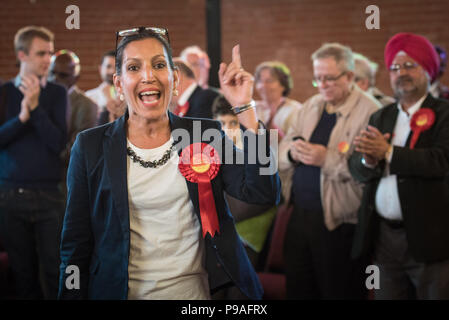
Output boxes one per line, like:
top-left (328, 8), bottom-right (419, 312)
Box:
top-left (103, 112), bottom-right (129, 233)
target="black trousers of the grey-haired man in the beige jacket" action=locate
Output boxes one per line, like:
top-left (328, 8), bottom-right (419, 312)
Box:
top-left (284, 208), bottom-right (367, 299)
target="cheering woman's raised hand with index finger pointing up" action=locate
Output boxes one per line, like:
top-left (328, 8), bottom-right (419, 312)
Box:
top-left (218, 45), bottom-right (254, 107)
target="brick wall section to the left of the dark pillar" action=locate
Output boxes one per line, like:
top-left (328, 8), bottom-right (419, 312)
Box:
top-left (0, 0), bottom-right (206, 90)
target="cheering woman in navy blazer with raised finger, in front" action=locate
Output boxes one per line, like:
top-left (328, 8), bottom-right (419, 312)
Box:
top-left (59, 27), bottom-right (280, 300)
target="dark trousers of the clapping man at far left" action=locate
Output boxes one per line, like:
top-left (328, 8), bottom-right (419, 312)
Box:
top-left (0, 188), bottom-right (65, 299)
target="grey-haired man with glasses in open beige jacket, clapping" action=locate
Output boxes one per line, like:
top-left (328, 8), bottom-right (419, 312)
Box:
top-left (279, 43), bottom-right (380, 299)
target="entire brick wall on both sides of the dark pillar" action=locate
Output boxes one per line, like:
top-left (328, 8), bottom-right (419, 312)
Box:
top-left (0, 0), bottom-right (449, 101)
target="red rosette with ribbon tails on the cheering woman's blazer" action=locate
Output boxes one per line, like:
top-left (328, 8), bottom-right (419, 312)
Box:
top-left (178, 142), bottom-right (220, 237)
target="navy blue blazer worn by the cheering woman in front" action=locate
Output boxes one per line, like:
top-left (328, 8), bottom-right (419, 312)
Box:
top-left (59, 112), bottom-right (280, 299)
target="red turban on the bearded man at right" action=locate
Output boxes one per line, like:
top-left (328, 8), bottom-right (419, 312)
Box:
top-left (384, 32), bottom-right (440, 81)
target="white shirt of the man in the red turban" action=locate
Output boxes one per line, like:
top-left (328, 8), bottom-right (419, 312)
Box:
top-left (376, 96), bottom-right (426, 220)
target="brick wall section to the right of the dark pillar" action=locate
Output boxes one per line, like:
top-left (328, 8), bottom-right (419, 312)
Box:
top-left (222, 0), bottom-right (449, 102)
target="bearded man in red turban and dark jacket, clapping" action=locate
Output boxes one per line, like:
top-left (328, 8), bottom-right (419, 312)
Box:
top-left (349, 33), bottom-right (449, 299)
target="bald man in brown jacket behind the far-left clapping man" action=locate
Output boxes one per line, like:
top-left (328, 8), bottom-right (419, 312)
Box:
top-left (48, 49), bottom-right (98, 191)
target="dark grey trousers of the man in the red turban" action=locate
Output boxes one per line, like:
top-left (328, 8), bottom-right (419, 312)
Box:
top-left (374, 220), bottom-right (449, 300)
